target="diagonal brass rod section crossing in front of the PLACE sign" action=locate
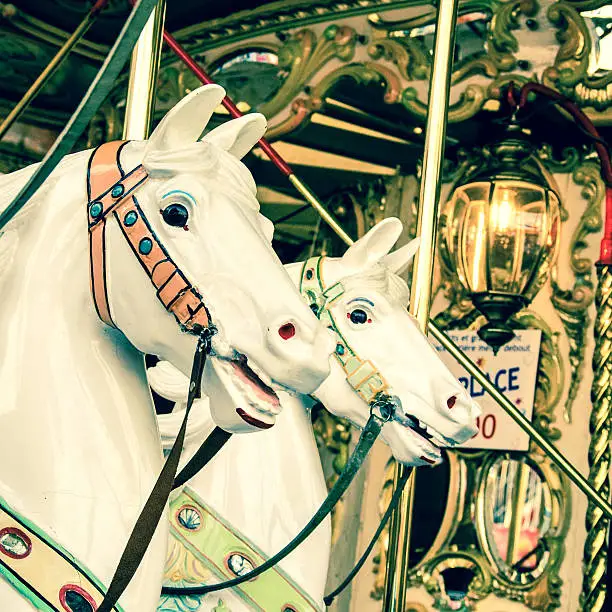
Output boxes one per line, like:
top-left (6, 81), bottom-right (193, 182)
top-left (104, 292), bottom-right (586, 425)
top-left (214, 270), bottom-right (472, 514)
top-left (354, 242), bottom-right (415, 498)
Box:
top-left (429, 321), bottom-right (612, 518)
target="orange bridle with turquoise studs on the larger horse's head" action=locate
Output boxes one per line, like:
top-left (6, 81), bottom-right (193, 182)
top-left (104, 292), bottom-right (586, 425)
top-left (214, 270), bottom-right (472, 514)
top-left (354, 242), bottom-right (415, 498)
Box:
top-left (87, 141), bottom-right (211, 334)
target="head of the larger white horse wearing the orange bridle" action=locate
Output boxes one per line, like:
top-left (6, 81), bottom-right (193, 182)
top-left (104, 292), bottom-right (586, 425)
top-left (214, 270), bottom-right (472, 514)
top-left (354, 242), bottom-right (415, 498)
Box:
top-left (89, 85), bottom-right (334, 420)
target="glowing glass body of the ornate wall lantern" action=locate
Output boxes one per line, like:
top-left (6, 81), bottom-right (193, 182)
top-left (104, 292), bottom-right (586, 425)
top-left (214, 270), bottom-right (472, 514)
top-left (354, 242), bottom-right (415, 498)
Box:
top-left (444, 179), bottom-right (560, 298)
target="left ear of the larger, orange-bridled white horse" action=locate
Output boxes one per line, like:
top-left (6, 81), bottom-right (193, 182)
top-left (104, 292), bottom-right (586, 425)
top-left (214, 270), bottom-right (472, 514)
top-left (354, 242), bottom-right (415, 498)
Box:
top-left (145, 85), bottom-right (225, 156)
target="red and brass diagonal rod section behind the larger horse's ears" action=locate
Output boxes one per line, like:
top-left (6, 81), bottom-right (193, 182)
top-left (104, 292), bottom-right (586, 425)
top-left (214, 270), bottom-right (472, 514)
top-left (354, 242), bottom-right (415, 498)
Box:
top-left (164, 30), bottom-right (353, 246)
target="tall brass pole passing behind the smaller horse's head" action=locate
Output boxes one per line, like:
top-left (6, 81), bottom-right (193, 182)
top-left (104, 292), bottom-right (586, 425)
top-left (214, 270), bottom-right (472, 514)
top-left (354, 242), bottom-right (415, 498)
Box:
top-left (383, 0), bottom-right (459, 612)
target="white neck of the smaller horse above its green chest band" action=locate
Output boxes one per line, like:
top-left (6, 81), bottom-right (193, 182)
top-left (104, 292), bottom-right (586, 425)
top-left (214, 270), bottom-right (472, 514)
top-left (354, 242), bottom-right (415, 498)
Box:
top-left (173, 394), bottom-right (331, 600)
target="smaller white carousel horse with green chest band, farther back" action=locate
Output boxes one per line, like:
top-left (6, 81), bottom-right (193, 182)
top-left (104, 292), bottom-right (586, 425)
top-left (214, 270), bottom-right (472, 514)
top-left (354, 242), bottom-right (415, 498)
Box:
top-left (149, 219), bottom-right (480, 612)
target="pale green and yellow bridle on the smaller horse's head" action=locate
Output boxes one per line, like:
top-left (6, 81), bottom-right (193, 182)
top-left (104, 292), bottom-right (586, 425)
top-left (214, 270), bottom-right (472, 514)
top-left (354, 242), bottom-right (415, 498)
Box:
top-left (300, 257), bottom-right (389, 404)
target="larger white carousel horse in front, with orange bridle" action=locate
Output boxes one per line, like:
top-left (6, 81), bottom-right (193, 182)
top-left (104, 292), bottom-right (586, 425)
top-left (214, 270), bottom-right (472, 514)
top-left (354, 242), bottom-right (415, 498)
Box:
top-left (0, 86), bottom-right (334, 612)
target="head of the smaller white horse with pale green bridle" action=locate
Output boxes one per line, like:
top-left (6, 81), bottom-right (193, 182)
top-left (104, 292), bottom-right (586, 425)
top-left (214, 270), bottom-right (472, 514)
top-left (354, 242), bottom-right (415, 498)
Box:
top-left (301, 218), bottom-right (480, 465)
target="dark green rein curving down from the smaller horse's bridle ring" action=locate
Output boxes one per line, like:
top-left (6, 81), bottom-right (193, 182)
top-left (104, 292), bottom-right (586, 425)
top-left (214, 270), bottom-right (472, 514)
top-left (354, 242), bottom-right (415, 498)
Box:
top-left (162, 398), bottom-right (395, 596)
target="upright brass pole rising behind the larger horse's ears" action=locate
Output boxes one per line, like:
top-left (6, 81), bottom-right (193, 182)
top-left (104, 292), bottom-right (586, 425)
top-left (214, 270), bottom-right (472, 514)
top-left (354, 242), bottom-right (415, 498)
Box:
top-left (123, 0), bottom-right (166, 140)
